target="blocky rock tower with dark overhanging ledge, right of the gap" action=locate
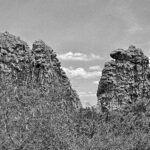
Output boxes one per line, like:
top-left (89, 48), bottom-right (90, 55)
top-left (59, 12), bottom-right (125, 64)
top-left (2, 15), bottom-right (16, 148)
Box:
top-left (97, 46), bottom-right (150, 111)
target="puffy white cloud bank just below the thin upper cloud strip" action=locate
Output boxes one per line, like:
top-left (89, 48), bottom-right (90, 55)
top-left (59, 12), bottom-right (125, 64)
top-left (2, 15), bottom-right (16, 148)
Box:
top-left (63, 67), bottom-right (101, 79)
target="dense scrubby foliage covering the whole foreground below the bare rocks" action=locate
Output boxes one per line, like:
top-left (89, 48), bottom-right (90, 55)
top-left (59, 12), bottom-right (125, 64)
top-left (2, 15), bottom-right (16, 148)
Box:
top-left (0, 69), bottom-right (150, 150)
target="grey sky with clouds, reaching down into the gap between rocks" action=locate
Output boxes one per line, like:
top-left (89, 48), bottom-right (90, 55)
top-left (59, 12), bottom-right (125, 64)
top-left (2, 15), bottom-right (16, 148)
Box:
top-left (0, 0), bottom-right (150, 106)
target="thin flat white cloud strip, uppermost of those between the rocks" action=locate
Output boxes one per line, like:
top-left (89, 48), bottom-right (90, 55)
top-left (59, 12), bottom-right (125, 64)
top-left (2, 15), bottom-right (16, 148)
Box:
top-left (58, 52), bottom-right (101, 61)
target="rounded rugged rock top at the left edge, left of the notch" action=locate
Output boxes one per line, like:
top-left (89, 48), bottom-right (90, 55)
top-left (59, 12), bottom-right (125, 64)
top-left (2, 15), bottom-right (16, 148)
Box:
top-left (0, 32), bottom-right (29, 72)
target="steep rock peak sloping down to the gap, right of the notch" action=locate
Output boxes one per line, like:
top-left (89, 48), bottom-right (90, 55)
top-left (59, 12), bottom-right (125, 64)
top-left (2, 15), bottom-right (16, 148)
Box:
top-left (31, 41), bottom-right (81, 110)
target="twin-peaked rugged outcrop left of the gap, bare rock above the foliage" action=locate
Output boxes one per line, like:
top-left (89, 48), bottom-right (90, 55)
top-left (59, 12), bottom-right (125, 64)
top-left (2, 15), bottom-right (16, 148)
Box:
top-left (0, 32), bottom-right (81, 110)
